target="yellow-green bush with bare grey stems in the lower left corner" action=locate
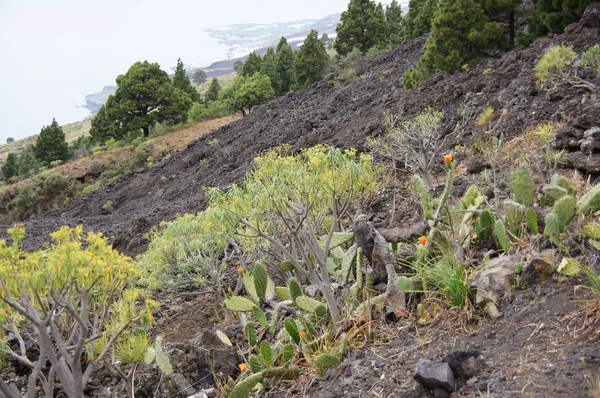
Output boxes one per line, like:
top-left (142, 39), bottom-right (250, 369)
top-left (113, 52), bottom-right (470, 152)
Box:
top-left (0, 226), bottom-right (157, 398)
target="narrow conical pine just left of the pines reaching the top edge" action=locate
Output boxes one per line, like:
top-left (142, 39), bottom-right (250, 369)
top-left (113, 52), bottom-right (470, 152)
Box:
top-left (294, 29), bottom-right (329, 88)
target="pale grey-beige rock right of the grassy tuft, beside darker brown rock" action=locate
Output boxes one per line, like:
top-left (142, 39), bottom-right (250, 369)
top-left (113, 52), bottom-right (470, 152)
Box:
top-left (471, 255), bottom-right (517, 319)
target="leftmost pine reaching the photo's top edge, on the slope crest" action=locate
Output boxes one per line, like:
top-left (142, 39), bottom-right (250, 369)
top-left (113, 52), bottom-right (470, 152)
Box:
top-left (333, 0), bottom-right (386, 55)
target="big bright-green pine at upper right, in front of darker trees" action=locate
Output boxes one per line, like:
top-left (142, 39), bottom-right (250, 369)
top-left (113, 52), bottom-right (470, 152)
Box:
top-left (419, 0), bottom-right (504, 75)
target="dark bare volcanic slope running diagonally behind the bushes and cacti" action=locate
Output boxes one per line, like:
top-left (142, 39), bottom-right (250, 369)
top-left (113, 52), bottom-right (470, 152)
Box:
top-left (0, 23), bottom-right (600, 256)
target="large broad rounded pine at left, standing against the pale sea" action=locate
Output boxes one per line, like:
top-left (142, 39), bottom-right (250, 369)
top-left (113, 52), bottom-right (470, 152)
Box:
top-left (107, 61), bottom-right (192, 137)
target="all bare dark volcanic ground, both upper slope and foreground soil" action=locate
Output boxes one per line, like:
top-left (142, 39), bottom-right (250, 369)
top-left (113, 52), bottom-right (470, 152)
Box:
top-left (0, 5), bottom-right (600, 397)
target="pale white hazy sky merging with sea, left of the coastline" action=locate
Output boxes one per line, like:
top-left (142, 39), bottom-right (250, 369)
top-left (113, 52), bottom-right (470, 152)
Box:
top-left (0, 0), bottom-right (349, 143)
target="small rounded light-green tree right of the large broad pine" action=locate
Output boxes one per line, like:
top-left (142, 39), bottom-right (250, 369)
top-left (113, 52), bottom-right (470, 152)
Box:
top-left (221, 72), bottom-right (275, 116)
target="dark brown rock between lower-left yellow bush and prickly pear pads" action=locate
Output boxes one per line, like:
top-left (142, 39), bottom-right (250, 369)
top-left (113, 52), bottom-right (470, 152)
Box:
top-left (190, 330), bottom-right (240, 388)
